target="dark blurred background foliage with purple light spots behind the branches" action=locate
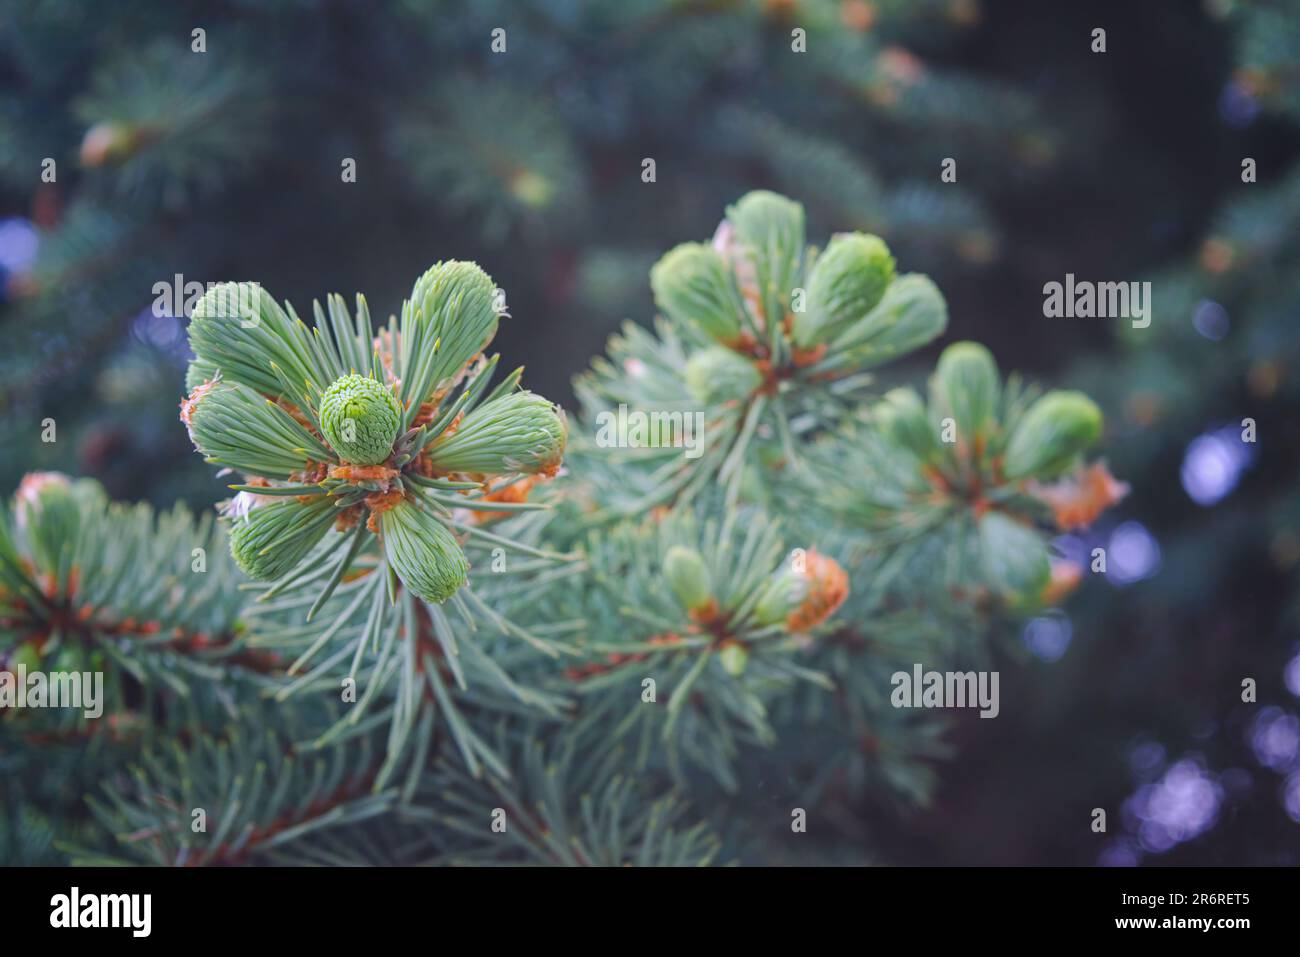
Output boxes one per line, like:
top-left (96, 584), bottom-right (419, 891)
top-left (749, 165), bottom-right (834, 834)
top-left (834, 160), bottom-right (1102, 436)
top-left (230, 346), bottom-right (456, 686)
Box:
top-left (0, 0), bottom-right (1300, 863)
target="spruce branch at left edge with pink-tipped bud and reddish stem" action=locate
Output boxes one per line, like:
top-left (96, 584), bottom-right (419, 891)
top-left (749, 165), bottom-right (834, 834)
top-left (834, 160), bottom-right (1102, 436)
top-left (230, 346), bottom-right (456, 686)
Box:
top-left (0, 473), bottom-right (276, 732)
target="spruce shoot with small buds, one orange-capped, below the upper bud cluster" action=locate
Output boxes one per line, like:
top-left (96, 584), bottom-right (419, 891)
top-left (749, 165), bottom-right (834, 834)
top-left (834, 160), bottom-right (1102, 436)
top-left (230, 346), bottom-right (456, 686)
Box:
top-left (564, 510), bottom-right (848, 788)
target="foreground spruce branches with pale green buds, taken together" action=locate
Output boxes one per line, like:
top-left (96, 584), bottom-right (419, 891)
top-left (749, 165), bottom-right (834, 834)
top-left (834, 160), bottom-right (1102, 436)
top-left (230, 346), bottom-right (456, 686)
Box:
top-left (0, 191), bottom-right (1118, 865)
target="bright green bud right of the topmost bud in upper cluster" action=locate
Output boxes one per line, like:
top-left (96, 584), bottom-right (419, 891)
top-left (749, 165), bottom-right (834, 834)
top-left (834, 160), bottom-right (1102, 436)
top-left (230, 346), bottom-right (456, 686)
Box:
top-left (793, 233), bottom-right (894, 348)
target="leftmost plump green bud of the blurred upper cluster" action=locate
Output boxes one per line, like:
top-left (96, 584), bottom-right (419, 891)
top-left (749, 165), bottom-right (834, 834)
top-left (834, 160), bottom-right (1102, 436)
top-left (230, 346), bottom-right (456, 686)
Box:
top-left (650, 243), bottom-right (741, 342)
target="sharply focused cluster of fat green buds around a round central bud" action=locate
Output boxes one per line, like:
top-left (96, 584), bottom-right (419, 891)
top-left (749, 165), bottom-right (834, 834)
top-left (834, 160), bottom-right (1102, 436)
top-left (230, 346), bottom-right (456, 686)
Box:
top-left (182, 261), bottom-right (566, 624)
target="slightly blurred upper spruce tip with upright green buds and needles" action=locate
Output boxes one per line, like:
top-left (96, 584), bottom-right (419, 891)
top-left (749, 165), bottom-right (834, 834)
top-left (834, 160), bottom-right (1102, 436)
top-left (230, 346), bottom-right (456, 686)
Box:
top-left (577, 191), bottom-right (948, 515)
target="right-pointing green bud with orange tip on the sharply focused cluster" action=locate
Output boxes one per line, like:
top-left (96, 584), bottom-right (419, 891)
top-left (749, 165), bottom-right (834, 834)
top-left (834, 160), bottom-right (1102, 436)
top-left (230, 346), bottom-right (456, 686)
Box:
top-left (429, 391), bottom-right (568, 475)
